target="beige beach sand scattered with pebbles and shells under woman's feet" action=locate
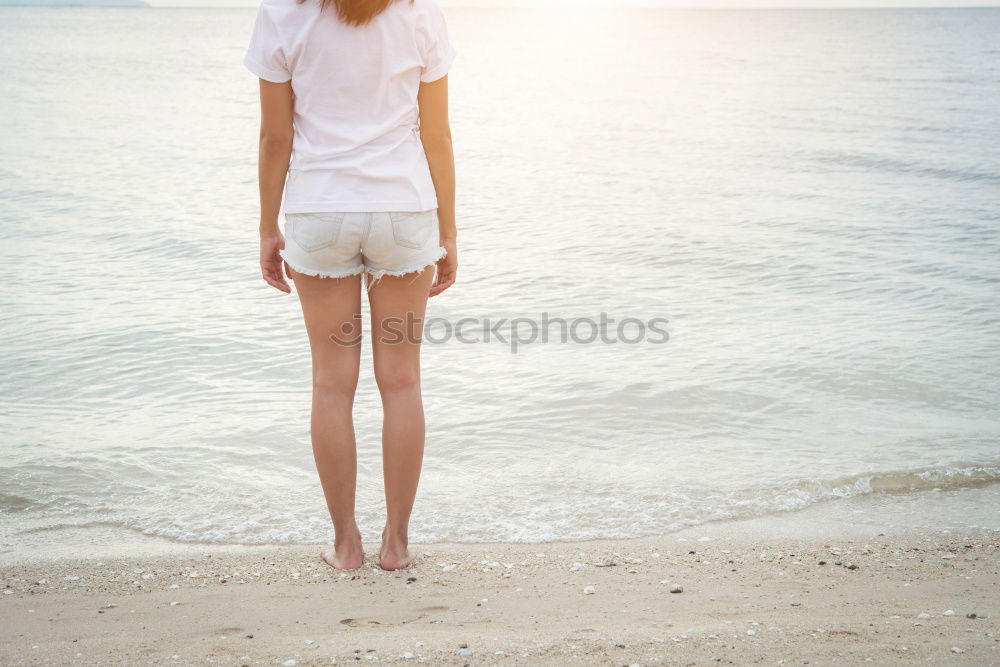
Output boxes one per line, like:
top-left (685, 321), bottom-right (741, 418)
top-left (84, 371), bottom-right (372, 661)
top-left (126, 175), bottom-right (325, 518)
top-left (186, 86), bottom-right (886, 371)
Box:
top-left (0, 525), bottom-right (1000, 665)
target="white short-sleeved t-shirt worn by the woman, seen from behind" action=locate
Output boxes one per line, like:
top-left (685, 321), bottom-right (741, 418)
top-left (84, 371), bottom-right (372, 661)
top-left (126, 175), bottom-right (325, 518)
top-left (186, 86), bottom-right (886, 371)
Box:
top-left (243, 0), bottom-right (455, 213)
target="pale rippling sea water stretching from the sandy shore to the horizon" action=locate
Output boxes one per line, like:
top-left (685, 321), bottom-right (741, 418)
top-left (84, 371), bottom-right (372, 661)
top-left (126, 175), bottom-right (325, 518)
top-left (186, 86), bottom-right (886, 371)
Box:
top-left (0, 8), bottom-right (1000, 550)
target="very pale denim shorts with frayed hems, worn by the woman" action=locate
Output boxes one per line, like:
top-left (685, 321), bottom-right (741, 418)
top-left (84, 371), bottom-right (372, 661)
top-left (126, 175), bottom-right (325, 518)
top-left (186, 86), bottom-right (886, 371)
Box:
top-left (279, 208), bottom-right (447, 287)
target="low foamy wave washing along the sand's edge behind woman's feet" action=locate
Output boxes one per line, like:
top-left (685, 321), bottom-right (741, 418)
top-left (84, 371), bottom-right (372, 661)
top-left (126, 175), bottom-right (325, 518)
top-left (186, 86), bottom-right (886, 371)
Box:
top-left (0, 462), bottom-right (1000, 544)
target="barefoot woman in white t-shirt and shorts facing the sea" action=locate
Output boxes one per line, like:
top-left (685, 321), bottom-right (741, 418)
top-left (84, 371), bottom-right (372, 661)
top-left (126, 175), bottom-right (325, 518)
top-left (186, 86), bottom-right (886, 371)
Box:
top-left (244, 0), bottom-right (458, 570)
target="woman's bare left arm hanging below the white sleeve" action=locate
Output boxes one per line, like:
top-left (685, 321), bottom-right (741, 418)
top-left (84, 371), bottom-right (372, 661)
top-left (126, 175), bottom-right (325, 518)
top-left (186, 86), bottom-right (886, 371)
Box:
top-left (257, 79), bottom-right (293, 293)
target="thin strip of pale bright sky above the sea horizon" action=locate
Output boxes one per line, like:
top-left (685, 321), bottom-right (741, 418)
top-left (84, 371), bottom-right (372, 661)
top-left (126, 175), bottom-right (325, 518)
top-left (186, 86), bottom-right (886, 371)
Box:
top-left (147, 0), bottom-right (1000, 7)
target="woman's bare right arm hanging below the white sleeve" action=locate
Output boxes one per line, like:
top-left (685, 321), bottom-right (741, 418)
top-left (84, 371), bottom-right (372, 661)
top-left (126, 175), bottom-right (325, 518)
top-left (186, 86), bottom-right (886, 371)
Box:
top-left (417, 75), bottom-right (458, 296)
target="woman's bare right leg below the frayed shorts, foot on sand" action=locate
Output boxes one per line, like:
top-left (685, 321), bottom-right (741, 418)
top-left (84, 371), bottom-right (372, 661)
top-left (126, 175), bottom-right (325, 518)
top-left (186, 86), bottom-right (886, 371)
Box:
top-left (368, 270), bottom-right (434, 570)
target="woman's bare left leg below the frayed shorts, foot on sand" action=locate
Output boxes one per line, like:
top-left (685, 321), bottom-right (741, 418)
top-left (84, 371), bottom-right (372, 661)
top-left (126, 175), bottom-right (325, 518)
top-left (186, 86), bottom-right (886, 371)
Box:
top-left (290, 272), bottom-right (364, 570)
